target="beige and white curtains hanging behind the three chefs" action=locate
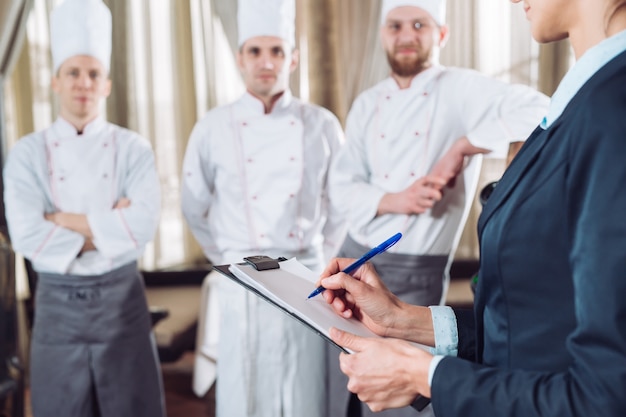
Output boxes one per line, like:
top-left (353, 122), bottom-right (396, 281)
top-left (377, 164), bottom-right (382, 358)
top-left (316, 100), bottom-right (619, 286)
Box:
top-left (0, 0), bottom-right (571, 268)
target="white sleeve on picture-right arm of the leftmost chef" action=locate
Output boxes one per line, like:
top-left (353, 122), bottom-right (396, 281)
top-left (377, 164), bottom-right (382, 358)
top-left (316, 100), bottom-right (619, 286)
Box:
top-left (87, 138), bottom-right (161, 258)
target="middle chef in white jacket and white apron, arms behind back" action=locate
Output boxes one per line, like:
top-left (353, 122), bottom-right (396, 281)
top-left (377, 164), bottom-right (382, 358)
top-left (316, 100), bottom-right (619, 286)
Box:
top-left (182, 0), bottom-right (344, 417)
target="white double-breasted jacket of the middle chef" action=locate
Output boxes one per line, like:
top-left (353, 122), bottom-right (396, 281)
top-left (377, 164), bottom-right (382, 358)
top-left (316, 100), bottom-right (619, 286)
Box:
top-left (182, 91), bottom-right (344, 264)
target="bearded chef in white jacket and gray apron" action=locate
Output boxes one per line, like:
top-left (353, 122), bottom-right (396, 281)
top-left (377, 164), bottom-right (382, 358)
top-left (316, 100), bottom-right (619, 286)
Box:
top-left (328, 0), bottom-right (548, 417)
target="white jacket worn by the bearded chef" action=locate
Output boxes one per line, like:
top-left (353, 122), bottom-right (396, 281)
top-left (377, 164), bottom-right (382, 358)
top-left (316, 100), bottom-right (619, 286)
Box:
top-left (331, 66), bottom-right (548, 255)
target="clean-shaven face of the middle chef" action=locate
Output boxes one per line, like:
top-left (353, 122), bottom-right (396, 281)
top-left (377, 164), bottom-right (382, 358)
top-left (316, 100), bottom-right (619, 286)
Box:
top-left (237, 36), bottom-right (298, 98)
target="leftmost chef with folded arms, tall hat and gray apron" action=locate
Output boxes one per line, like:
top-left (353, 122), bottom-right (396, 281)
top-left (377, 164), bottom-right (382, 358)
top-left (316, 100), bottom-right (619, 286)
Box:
top-left (4, 0), bottom-right (165, 417)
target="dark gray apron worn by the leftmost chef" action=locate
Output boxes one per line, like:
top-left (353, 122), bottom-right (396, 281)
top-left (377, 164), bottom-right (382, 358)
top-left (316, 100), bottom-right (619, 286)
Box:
top-left (30, 262), bottom-right (165, 417)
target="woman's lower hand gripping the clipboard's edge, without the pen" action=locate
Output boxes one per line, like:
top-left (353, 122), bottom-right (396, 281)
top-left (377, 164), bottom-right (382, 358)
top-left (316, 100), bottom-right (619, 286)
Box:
top-left (330, 328), bottom-right (433, 412)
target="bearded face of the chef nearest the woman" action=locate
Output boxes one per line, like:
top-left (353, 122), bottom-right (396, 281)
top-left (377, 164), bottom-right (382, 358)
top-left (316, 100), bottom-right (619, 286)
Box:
top-left (380, 6), bottom-right (448, 77)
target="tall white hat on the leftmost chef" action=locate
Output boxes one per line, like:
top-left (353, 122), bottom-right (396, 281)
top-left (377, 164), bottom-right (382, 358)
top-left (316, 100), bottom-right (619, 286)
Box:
top-left (50, 0), bottom-right (111, 73)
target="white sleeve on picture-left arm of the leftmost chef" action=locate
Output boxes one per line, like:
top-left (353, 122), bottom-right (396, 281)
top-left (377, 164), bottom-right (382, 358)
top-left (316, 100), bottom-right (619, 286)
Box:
top-left (4, 139), bottom-right (85, 274)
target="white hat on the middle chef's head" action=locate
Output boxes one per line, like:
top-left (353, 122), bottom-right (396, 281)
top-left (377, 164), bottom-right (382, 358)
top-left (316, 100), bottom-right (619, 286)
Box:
top-left (237, 0), bottom-right (296, 47)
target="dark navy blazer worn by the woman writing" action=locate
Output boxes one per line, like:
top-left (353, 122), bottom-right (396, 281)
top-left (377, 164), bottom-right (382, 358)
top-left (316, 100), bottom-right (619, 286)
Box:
top-left (432, 48), bottom-right (626, 417)
